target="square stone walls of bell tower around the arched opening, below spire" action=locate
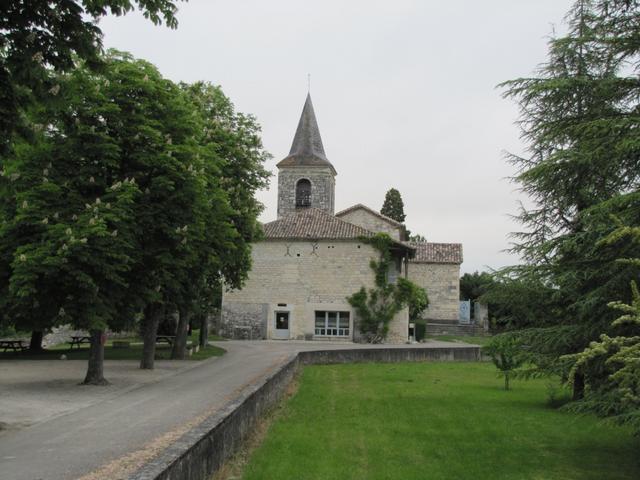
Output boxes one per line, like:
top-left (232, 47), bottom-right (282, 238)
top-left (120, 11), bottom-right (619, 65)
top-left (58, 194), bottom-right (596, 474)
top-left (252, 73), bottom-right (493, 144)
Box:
top-left (278, 167), bottom-right (336, 218)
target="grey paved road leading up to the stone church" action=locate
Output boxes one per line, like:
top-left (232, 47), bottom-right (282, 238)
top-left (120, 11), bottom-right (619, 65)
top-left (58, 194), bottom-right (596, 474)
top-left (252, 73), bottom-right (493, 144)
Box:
top-left (0, 341), bottom-right (476, 480)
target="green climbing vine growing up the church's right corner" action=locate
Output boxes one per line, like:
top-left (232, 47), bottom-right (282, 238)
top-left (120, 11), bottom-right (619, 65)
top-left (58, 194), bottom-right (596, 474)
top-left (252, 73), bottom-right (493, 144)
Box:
top-left (347, 233), bottom-right (429, 343)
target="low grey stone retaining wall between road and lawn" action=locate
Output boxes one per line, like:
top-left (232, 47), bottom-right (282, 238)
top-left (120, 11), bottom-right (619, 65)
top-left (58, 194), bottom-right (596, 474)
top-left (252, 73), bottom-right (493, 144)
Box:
top-left (129, 347), bottom-right (481, 480)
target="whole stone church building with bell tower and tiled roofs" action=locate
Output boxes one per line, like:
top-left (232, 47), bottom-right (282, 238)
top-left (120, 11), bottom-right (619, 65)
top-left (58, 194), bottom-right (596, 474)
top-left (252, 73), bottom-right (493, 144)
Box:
top-left (220, 95), bottom-right (462, 343)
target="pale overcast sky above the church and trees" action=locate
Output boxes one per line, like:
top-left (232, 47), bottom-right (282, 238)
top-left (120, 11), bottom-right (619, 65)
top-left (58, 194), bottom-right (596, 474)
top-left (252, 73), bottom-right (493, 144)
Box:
top-left (100, 0), bottom-right (573, 273)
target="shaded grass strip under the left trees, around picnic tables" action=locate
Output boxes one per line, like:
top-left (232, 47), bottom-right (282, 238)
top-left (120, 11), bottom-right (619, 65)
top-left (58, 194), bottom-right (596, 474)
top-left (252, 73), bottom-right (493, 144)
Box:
top-left (0, 330), bottom-right (225, 360)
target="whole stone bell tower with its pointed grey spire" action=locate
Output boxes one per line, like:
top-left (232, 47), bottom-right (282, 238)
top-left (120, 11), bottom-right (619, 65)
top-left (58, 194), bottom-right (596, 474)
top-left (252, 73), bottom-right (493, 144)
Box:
top-left (277, 94), bottom-right (337, 218)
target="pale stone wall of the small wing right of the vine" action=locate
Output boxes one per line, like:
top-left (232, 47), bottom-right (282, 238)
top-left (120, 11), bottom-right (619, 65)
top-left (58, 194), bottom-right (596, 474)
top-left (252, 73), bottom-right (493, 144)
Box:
top-left (409, 263), bottom-right (460, 321)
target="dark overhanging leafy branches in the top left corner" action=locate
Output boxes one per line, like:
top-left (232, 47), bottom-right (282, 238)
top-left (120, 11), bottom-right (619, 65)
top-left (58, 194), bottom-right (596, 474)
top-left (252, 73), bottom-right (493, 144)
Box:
top-left (0, 0), bottom-right (185, 152)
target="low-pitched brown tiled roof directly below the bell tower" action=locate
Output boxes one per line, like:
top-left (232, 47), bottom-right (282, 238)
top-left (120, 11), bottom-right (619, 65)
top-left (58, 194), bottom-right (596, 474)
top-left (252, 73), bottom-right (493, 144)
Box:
top-left (262, 207), bottom-right (414, 252)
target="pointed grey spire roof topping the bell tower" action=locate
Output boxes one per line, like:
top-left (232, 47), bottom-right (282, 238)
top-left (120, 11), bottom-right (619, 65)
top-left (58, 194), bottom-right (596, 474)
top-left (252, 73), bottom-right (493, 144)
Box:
top-left (277, 94), bottom-right (336, 174)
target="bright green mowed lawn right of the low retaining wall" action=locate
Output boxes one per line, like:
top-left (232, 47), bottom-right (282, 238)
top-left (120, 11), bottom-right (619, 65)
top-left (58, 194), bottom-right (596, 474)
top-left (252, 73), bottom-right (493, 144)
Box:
top-left (243, 363), bottom-right (640, 480)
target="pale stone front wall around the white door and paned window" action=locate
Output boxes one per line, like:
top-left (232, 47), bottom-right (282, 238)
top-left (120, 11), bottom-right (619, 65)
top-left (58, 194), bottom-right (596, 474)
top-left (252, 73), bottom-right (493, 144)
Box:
top-left (220, 241), bottom-right (409, 343)
